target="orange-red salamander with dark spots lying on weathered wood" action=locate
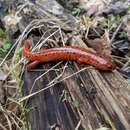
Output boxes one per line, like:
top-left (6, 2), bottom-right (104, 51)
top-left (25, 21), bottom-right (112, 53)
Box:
top-left (23, 40), bottom-right (116, 71)
